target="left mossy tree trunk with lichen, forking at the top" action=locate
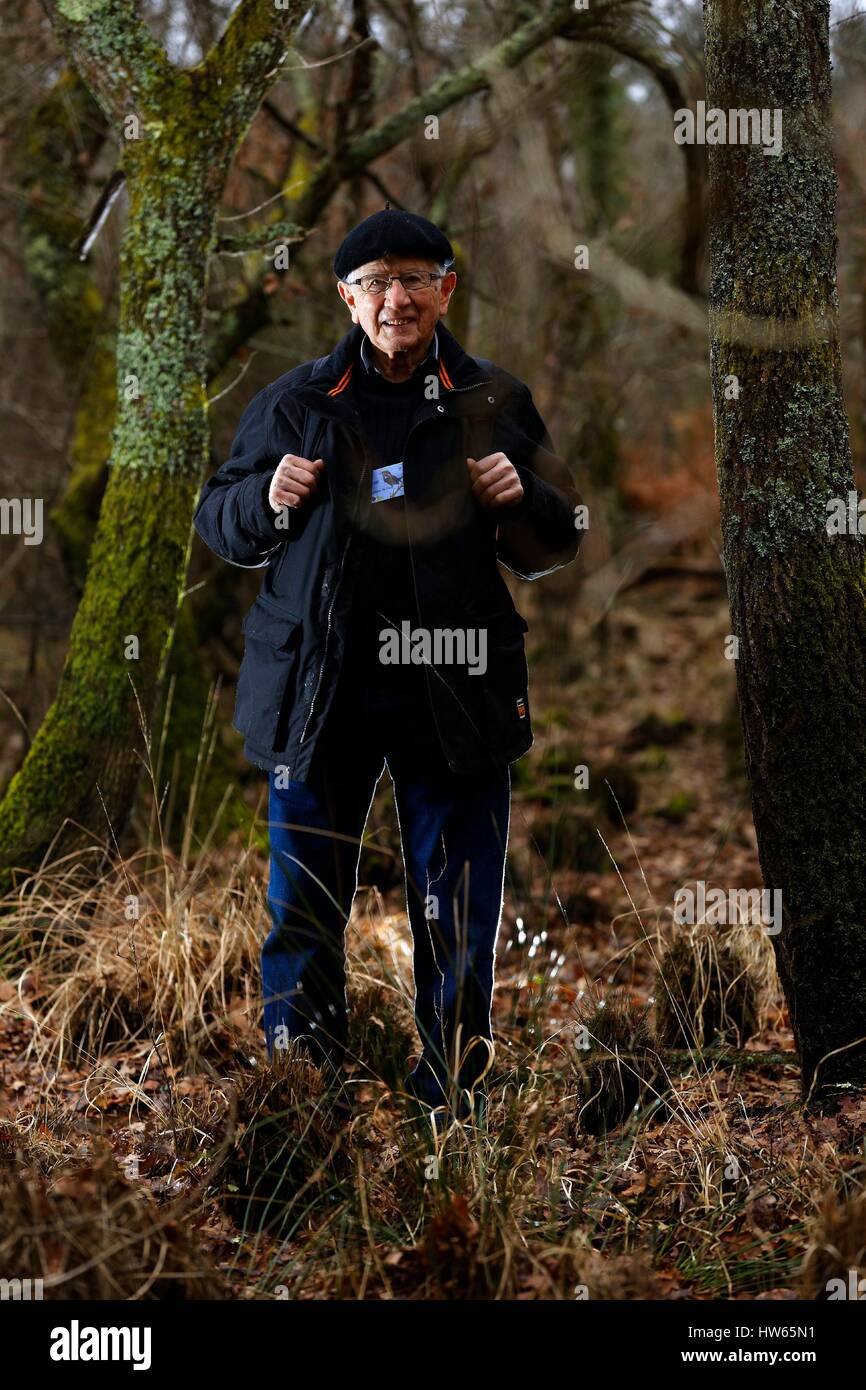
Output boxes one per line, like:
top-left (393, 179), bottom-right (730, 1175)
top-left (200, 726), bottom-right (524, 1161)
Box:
top-left (0, 0), bottom-right (300, 866)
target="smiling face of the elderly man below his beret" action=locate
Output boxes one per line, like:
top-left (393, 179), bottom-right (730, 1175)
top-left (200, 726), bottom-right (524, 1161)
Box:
top-left (338, 256), bottom-right (457, 357)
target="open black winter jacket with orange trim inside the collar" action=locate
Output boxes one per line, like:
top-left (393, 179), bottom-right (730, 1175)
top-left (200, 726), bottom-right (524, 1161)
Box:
top-left (195, 322), bottom-right (581, 781)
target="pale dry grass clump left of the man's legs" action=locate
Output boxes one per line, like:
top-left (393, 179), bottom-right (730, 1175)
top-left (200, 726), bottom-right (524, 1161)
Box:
top-left (1, 852), bottom-right (265, 1066)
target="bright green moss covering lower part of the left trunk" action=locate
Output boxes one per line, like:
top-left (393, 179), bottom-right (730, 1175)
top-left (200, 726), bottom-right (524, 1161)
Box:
top-left (0, 470), bottom-right (197, 863)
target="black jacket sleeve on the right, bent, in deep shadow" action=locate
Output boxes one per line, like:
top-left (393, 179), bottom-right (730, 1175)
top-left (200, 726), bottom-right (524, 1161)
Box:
top-left (496, 384), bottom-right (582, 580)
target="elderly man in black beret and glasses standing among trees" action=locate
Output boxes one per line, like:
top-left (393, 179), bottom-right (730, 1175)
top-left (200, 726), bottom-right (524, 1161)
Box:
top-left (195, 209), bottom-right (580, 1115)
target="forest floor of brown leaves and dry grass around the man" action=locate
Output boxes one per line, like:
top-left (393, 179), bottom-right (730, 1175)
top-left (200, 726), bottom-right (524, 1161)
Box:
top-left (0, 558), bottom-right (866, 1300)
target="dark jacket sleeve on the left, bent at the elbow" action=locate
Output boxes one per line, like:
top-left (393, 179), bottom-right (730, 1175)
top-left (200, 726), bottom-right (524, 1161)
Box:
top-left (193, 386), bottom-right (289, 570)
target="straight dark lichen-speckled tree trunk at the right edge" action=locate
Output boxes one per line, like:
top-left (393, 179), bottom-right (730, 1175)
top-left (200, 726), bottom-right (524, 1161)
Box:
top-left (705, 0), bottom-right (866, 1104)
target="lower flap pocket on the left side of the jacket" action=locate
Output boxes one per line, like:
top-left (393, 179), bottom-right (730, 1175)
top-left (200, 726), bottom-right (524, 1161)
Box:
top-left (232, 595), bottom-right (302, 749)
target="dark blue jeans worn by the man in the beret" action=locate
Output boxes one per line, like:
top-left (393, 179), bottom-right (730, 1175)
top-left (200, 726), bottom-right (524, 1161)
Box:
top-left (261, 669), bottom-right (510, 1105)
